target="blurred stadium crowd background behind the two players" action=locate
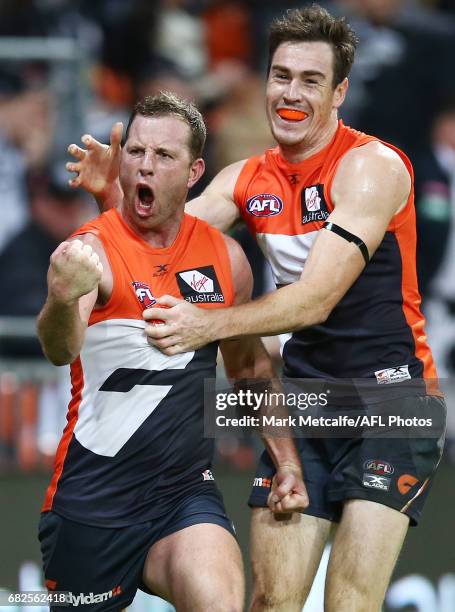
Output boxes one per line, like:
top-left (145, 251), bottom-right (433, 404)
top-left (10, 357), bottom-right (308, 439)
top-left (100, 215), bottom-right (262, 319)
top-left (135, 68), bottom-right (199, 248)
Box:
top-left (0, 0), bottom-right (455, 612)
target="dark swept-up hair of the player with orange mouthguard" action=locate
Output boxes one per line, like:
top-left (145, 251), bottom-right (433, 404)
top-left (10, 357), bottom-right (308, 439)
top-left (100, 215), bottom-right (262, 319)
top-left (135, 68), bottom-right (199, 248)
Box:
top-left (268, 4), bottom-right (358, 87)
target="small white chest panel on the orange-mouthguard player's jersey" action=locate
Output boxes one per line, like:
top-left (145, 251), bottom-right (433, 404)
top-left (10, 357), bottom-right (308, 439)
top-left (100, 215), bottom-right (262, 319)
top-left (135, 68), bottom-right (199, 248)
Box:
top-left (256, 231), bottom-right (318, 285)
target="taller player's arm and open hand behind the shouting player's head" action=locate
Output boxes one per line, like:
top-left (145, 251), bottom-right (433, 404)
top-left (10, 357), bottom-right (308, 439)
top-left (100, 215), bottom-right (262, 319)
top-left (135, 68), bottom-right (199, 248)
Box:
top-left (66, 123), bottom-right (246, 232)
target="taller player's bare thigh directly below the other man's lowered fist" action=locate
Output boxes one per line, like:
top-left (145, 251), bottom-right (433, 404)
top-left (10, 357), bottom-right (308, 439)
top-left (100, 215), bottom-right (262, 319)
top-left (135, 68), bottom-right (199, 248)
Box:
top-left (250, 508), bottom-right (332, 612)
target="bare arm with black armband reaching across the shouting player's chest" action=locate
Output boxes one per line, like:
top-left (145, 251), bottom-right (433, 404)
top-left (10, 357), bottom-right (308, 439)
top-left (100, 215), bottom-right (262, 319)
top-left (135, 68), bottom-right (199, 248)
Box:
top-left (149, 142), bottom-right (411, 355)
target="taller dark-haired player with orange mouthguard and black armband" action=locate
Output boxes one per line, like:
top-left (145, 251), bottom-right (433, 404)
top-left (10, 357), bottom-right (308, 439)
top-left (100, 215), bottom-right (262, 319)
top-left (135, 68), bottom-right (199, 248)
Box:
top-left (68, 5), bottom-right (444, 612)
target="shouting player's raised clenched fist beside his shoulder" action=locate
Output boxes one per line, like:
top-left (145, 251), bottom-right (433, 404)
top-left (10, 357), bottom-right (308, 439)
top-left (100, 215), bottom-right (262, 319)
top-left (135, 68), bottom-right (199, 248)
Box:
top-left (49, 240), bottom-right (103, 303)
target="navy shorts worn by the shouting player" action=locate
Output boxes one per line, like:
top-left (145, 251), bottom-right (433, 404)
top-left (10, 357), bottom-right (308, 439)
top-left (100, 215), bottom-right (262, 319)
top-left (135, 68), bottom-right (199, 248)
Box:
top-left (39, 486), bottom-right (234, 612)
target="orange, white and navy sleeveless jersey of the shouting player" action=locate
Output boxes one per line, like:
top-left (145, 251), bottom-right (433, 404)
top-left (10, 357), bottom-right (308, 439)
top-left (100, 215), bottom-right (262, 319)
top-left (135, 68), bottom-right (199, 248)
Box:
top-left (43, 210), bottom-right (234, 527)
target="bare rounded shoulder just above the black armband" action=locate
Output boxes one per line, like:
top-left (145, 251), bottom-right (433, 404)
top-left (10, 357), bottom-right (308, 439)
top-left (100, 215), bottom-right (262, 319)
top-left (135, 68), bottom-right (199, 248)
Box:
top-left (331, 141), bottom-right (411, 212)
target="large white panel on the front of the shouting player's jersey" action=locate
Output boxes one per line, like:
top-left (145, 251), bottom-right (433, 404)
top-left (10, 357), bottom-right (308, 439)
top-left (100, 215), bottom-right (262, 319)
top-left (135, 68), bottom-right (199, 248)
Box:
top-left (74, 319), bottom-right (194, 457)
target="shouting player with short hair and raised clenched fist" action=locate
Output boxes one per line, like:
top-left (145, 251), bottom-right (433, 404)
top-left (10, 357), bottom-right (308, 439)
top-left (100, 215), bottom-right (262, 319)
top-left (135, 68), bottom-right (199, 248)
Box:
top-left (38, 94), bottom-right (307, 612)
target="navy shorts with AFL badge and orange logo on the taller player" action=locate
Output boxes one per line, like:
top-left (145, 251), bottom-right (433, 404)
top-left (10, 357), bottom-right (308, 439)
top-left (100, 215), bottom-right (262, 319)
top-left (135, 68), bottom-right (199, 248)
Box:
top-left (248, 396), bottom-right (446, 525)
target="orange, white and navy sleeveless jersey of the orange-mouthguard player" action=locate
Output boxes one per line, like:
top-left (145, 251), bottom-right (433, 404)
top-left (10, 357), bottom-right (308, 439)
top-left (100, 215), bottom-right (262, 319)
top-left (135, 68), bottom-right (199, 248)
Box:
top-left (234, 121), bottom-right (436, 392)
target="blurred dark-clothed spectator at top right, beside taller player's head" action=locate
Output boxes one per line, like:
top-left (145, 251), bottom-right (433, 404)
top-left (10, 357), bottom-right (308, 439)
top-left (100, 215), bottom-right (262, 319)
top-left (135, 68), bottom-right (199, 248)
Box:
top-left (332, 0), bottom-right (455, 158)
